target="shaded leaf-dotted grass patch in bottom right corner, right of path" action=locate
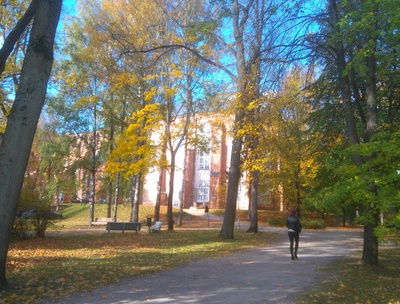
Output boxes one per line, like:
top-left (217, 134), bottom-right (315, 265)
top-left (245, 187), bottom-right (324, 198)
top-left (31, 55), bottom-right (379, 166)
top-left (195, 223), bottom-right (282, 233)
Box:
top-left (298, 245), bottom-right (400, 304)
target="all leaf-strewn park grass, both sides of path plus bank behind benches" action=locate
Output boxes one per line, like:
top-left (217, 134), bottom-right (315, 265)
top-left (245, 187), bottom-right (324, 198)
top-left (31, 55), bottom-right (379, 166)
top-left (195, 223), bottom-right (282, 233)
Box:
top-left (0, 204), bottom-right (400, 304)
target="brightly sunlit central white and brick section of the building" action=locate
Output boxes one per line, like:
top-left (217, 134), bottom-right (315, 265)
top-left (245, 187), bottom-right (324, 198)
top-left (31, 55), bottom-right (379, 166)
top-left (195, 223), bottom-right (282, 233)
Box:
top-left (142, 116), bottom-right (248, 209)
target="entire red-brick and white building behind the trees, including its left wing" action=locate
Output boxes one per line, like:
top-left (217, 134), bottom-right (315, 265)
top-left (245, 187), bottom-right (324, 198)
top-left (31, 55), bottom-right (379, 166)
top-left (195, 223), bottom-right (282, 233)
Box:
top-left (65, 115), bottom-right (285, 211)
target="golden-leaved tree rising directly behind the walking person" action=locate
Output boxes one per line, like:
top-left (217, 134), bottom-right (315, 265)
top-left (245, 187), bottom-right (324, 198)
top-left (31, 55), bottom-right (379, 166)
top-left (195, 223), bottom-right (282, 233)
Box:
top-left (264, 66), bottom-right (318, 214)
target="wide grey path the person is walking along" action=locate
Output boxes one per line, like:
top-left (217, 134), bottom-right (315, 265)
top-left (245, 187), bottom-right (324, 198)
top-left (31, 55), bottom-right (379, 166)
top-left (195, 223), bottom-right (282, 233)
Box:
top-left (48, 217), bottom-right (362, 304)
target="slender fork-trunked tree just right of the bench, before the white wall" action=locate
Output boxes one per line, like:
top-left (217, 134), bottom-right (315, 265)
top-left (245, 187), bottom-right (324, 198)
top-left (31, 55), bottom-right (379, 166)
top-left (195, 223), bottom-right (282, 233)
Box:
top-left (82, 1), bottom-right (219, 229)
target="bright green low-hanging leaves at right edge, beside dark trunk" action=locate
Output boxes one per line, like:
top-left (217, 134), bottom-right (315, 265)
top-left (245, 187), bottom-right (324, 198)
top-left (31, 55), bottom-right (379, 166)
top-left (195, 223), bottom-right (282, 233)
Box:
top-left (308, 128), bottom-right (400, 237)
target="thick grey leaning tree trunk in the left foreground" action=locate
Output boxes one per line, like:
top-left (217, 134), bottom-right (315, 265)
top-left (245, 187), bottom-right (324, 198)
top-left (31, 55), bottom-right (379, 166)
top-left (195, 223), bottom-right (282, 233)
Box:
top-left (0, 0), bottom-right (62, 288)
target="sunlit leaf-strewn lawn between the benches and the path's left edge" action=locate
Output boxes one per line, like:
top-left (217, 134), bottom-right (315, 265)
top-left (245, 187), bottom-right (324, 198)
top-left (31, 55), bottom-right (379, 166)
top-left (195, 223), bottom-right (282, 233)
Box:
top-left (1, 230), bottom-right (272, 303)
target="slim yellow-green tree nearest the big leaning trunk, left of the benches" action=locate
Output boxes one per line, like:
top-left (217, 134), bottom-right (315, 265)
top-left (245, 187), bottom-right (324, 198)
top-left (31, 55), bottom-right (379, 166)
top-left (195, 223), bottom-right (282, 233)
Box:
top-left (52, 14), bottom-right (107, 225)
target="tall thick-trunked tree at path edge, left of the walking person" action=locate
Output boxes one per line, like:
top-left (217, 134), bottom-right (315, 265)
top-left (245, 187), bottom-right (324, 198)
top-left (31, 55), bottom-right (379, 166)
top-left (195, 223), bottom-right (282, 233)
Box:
top-left (202, 0), bottom-right (308, 238)
